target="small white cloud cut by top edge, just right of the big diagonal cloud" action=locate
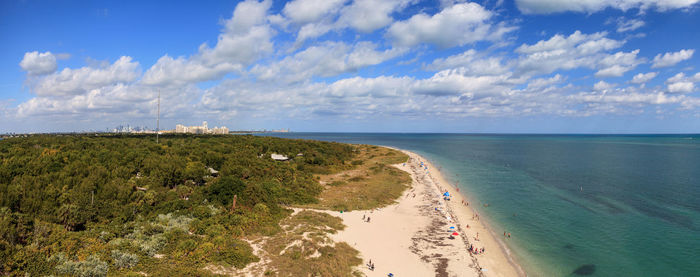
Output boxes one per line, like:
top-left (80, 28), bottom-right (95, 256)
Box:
top-left (282, 0), bottom-right (347, 23)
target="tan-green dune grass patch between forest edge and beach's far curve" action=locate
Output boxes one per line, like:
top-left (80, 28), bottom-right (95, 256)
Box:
top-left (304, 145), bottom-right (411, 211)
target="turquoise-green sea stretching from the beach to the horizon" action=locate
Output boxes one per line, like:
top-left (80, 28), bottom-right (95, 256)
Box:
top-left (262, 133), bottom-right (700, 276)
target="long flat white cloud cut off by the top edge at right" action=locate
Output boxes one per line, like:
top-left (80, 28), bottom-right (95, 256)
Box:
top-left (515, 0), bottom-right (699, 14)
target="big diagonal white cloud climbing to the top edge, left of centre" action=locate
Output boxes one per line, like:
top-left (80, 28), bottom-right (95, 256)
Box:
top-left (142, 0), bottom-right (273, 85)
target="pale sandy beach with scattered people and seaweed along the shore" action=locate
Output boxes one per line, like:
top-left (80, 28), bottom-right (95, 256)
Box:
top-left (320, 150), bottom-right (525, 276)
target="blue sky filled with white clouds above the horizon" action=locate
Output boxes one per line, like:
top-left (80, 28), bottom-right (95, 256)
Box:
top-left (0, 0), bottom-right (700, 133)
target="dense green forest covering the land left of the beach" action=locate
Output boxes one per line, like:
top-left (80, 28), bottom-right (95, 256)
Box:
top-left (0, 134), bottom-right (356, 276)
